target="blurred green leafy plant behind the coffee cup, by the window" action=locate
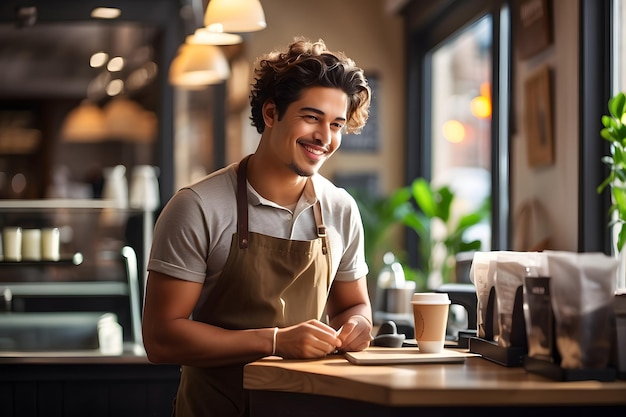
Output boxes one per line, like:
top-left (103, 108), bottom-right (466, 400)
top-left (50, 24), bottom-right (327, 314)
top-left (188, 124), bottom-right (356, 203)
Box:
top-left (350, 178), bottom-right (489, 290)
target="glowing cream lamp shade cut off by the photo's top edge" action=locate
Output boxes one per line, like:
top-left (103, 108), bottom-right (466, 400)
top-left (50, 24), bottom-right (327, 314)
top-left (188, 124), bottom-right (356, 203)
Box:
top-left (204, 0), bottom-right (267, 32)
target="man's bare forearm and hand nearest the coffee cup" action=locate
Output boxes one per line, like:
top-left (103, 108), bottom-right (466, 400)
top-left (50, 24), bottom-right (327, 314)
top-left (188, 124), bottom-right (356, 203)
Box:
top-left (327, 277), bottom-right (372, 352)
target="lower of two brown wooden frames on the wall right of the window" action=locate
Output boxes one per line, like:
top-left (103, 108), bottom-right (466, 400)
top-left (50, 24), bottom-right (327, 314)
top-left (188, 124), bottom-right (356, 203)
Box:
top-left (524, 65), bottom-right (554, 167)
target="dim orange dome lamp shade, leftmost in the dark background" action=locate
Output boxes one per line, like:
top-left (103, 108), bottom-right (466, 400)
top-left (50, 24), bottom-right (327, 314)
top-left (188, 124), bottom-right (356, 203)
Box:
top-left (61, 101), bottom-right (107, 142)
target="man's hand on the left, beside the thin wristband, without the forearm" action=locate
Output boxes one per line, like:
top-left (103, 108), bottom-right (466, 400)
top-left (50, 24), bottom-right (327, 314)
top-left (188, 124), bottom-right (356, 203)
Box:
top-left (276, 320), bottom-right (341, 359)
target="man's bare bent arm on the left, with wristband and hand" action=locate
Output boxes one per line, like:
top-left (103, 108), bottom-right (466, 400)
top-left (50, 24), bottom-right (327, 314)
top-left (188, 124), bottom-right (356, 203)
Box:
top-left (142, 272), bottom-right (341, 366)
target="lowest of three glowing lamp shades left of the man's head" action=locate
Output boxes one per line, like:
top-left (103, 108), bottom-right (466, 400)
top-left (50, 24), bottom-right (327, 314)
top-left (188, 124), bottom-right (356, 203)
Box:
top-left (169, 43), bottom-right (230, 89)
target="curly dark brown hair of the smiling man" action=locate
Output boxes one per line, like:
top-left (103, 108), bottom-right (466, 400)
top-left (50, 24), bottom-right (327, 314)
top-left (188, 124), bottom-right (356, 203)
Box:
top-left (250, 38), bottom-right (371, 133)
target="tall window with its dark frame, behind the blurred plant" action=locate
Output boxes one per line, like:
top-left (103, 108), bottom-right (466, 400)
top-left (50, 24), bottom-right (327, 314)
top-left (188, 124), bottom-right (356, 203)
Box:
top-left (406, 0), bottom-right (511, 281)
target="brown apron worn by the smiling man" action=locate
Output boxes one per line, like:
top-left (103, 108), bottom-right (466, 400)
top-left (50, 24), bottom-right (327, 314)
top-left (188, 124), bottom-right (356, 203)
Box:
top-left (174, 157), bottom-right (331, 417)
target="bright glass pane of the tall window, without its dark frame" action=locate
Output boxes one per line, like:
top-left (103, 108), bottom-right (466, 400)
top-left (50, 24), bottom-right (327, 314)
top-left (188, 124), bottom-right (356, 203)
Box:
top-left (430, 15), bottom-right (493, 250)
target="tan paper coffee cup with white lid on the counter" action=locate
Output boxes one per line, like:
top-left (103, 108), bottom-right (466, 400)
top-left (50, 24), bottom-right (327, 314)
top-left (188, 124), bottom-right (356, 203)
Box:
top-left (411, 293), bottom-right (450, 353)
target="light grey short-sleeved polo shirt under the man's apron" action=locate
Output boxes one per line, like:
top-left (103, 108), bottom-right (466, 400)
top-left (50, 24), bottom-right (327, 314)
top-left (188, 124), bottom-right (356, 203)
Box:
top-left (148, 164), bottom-right (368, 295)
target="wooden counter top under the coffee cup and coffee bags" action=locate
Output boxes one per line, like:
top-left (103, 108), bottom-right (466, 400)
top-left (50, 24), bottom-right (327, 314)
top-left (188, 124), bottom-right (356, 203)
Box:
top-left (244, 355), bottom-right (626, 406)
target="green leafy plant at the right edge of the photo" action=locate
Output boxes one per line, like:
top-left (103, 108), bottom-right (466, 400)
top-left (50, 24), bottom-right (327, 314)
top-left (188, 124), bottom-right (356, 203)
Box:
top-left (598, 93), bottom-right (626, 252)
